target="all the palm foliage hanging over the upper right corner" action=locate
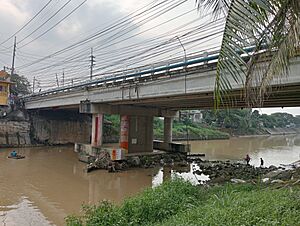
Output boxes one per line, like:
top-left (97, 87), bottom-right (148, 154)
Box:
top-left (196, 0), bottom-right (300, 107)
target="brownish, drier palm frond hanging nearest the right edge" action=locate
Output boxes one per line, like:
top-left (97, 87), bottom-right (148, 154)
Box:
top-left (245, 0), bottom-right (300, 106)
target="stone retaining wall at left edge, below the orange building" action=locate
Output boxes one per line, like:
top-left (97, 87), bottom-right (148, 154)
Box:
top-left (0, 120), bottom-right (31, 147)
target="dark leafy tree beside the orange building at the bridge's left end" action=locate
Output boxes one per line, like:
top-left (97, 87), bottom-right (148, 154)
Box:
top-left (10, 74), bottom-right (31, 96)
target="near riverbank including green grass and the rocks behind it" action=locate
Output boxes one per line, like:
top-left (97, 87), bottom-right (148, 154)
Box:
top-left (71, 146), bottom-right (300, 226)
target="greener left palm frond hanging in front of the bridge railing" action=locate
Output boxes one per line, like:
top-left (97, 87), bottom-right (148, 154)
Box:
top-left (215, 0), bottom-right (268, 108)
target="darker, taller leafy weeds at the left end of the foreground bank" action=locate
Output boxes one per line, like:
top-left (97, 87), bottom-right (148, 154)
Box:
top-left (66, 179), bottom-right (205, 226)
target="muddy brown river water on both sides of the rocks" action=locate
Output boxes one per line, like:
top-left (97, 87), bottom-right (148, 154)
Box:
top-left (0, 135), bottom-right (300, 226)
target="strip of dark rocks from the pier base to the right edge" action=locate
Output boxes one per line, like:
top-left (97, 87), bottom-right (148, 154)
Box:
top-left (87, 149), bottom-right (300, 184)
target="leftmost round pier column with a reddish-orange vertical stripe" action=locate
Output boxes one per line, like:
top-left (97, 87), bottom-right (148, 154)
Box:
top-left (91, 114), bottom-right (103, 147)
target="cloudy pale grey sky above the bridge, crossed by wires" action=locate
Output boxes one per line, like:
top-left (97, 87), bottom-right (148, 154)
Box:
top-left (0, 0), bottom-right (300, 115)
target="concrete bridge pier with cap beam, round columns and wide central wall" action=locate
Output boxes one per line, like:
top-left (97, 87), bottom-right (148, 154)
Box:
top-left (80, 102), bottom-right (176, 153)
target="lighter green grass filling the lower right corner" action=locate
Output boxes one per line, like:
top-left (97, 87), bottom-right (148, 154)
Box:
top-left (157, 186), bottom-right (300, 226)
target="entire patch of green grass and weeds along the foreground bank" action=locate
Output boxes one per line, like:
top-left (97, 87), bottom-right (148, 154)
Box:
top-left (66, 179), bottom-right (300, 226)
